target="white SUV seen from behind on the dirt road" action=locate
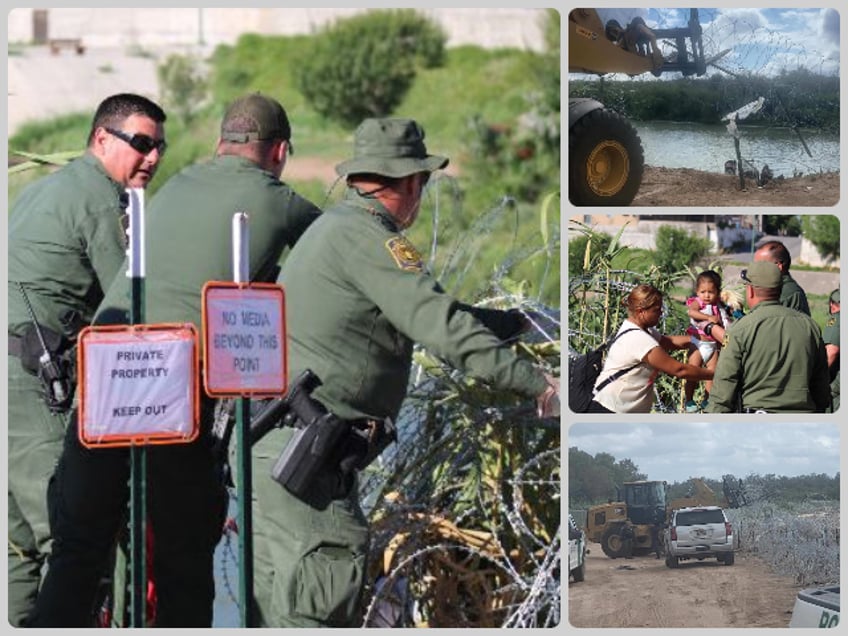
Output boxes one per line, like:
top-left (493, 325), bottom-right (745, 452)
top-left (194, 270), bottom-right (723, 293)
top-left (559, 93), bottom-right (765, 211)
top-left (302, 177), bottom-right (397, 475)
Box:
top-left (664, 506), bottom-right (733, 568)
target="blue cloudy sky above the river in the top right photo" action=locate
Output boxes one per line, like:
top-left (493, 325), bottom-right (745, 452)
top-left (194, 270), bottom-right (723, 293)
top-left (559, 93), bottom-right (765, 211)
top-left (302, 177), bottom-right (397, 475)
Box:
top-left (576, 7), bottom-right (839, 79)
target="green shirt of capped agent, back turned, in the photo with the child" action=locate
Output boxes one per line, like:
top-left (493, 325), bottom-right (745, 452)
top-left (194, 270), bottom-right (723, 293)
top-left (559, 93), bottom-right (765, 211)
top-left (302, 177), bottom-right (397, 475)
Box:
top-left (707, 300), bottom-right (830, 413)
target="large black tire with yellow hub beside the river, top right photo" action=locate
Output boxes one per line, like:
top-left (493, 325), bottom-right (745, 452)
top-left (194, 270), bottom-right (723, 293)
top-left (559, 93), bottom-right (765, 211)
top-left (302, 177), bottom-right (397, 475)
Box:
top-left (568, 108), bottom-right (645, 205)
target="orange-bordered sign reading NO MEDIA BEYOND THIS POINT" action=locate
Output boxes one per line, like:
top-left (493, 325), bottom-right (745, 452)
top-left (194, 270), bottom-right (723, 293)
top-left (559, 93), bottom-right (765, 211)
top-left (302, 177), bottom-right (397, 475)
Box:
top-left (202, 281), bottom-right (288, 397)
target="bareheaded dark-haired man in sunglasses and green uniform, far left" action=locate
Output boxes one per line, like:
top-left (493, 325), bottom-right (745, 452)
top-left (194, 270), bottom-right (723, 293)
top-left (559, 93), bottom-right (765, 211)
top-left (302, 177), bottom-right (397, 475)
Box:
top-left (7, 94), bottom-right (165, 626)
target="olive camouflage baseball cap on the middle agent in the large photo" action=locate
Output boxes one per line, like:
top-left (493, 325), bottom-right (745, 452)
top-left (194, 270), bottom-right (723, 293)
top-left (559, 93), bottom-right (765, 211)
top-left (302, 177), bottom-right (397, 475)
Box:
top-left (221, 93), bottom-right (291, 144)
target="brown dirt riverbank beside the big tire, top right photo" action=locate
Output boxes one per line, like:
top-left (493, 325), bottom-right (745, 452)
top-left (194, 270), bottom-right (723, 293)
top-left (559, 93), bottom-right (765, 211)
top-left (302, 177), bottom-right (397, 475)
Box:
top-left (631, 166), bottom-right (839, 207)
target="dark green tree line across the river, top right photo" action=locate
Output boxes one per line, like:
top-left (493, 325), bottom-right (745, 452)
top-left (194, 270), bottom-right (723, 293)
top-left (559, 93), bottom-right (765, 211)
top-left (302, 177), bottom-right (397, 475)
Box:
top-left (568, 68), bottom-right (839, 133)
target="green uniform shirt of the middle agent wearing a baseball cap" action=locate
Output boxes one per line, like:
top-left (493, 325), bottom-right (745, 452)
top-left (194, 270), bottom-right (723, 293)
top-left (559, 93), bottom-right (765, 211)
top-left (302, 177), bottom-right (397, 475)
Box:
top-left (96, 156), bottom-right (320, 329)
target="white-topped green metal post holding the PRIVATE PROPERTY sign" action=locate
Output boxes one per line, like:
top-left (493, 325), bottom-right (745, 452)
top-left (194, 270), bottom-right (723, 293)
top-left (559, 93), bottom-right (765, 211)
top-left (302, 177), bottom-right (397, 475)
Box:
top-left (127, 188), bottom-right (147, 627)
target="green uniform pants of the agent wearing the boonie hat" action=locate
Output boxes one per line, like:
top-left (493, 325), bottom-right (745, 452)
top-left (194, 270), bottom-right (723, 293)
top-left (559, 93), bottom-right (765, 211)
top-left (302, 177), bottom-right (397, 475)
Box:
top-left (252, 428), bottom-right (368, 627)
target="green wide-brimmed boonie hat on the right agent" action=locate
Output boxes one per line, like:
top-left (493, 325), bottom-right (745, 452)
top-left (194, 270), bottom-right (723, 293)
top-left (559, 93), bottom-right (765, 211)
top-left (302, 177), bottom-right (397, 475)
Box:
top-left (336, 118), bottom-right (448, 179)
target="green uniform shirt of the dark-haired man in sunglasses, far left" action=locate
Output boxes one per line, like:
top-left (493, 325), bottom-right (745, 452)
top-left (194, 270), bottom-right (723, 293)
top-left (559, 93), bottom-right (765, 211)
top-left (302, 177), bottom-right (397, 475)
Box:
top-left (7, 154), bottom-right (126, 334)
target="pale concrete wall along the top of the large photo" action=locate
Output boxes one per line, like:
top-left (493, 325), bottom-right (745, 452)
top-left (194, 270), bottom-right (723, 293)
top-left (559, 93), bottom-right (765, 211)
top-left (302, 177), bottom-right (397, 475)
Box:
top-left (8, 8), bottom-right (545, 50)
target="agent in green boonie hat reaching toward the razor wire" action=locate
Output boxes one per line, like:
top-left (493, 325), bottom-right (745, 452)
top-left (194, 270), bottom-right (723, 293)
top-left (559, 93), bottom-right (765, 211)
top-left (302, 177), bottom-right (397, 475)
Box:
top-left (248, 118), bottom-right (558, 627)
